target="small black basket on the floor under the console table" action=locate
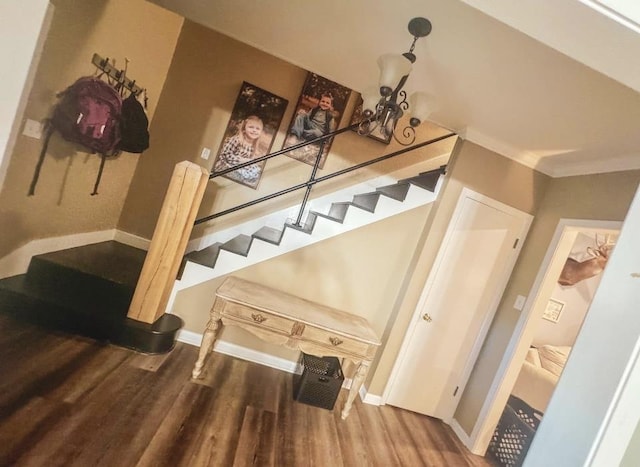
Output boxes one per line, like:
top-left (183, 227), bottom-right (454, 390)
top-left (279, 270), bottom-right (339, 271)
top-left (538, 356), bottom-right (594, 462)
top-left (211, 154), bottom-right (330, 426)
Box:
top-left (293, 353), bottom-right (344, 410)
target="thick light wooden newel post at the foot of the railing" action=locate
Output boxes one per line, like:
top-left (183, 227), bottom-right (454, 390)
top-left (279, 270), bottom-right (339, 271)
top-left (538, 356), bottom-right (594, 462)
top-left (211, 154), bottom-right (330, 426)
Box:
top-left (127, 161), bottom-right (209, 323)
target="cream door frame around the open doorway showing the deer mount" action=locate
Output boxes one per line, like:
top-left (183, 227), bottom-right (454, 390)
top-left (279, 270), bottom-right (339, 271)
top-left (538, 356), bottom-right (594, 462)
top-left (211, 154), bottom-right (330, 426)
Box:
top-left (464, 218), bottom-right (622, 455)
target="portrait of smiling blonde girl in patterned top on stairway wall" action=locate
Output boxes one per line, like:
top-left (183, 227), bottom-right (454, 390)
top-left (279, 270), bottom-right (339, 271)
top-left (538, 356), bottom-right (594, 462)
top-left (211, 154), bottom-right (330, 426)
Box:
top-left (213, 82), bottom-right (289, 190)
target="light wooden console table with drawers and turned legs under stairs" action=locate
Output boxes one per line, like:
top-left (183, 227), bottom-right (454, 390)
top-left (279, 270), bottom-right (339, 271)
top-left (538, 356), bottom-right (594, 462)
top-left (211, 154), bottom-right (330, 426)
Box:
top-left (192, 276), bottom-right (380, 420)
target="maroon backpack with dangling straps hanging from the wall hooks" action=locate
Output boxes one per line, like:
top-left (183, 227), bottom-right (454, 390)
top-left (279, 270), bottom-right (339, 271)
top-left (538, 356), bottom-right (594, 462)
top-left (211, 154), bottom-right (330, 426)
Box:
top-left (29, 76), bottom-right (122, 195)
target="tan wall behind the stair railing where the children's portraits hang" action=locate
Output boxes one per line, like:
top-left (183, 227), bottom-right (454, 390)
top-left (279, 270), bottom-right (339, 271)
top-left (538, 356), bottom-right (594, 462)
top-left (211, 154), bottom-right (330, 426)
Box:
top-left (119, 21), bottom-right (455, 238)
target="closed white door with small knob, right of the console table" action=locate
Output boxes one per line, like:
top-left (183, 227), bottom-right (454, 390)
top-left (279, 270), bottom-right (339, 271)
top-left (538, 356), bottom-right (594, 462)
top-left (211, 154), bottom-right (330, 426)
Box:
top-left (386, 189), bottom-right (531, 419)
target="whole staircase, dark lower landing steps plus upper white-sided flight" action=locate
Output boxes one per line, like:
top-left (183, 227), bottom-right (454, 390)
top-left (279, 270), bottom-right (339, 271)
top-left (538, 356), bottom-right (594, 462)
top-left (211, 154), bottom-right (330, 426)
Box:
top-left (0, 167), bottom-right (444, 353)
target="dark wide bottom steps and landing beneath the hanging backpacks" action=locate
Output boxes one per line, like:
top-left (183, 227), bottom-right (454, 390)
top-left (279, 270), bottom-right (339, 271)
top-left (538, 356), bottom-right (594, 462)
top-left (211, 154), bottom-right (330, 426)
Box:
top-left (0, 241), bottom-right (183, 353)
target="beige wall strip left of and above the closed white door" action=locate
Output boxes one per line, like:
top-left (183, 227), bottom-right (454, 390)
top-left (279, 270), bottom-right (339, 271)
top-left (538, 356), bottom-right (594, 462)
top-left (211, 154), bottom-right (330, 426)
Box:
top-left (370, 140), bottom-right (549, 394)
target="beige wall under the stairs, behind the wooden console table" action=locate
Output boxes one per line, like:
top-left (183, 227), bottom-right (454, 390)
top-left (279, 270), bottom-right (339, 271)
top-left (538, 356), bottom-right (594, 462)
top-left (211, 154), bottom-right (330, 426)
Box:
top-left (173, 205), bottom-right (431, 374)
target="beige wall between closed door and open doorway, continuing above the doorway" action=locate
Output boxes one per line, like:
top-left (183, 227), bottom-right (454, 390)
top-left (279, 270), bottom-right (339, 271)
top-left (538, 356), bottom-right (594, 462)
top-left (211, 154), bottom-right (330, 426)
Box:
top-left (455, 170), bottom-right (640, 433)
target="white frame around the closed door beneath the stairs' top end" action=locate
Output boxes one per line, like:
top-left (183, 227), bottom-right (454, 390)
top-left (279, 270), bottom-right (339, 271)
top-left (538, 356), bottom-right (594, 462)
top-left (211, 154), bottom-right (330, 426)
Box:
top-left (382, 187), bottom-right (533, 423)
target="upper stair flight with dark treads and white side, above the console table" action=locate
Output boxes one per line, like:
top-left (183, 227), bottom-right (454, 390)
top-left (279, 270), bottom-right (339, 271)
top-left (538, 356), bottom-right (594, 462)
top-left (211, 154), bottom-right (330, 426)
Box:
top-left (176, 166), bottom-right (445, 292)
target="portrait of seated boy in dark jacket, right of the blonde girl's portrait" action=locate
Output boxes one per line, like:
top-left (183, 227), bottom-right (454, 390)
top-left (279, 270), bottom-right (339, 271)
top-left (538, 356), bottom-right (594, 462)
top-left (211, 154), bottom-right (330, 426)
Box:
top-left (282, 73), bottom-right (351, 168)
